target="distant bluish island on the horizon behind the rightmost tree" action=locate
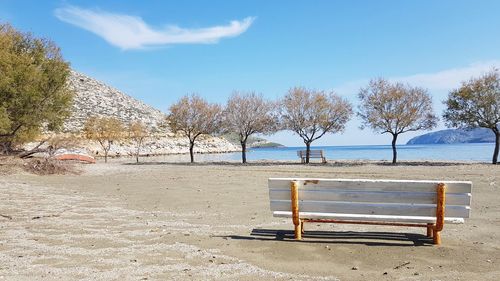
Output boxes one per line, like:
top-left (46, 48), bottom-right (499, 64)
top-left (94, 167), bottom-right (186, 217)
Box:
top-left (406, 128), bottom-right (495, 145)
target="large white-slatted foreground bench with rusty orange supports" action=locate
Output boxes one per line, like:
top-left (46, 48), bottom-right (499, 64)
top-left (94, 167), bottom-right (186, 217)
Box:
top-left (269, 178), bottom-right (472, 245)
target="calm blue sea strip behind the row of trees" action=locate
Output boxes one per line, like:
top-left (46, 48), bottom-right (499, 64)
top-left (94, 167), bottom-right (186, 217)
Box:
top-left (155, 143), bottom-right (494, 162)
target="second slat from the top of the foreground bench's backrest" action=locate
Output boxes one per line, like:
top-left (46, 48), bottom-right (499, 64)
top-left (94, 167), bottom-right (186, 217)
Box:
top-left (269, 188), bottom-right (471, 206)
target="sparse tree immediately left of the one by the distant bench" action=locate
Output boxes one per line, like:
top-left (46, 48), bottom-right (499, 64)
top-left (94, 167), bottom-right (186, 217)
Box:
top-left (224, 92), bottom-right (278, 163)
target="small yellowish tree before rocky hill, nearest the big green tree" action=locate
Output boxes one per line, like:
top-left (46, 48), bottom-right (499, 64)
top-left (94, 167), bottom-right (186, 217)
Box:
top-left (83, 117), bottom-right (124, 163)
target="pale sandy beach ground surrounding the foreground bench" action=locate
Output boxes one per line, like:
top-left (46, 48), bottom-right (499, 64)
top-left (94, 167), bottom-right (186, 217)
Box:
top-left (0, 160), bottom-right (500, 280)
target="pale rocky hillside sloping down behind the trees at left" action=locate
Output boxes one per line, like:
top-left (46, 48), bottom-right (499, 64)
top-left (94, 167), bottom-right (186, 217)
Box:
top-left (51, 71), bottom-right (238, 156)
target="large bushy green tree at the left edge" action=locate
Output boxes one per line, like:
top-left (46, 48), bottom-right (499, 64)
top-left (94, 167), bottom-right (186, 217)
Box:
top-left (0, 24), bottom-right (73, 153)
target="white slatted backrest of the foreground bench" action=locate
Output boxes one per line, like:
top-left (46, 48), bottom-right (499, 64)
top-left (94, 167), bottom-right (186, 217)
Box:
top-left (269, 178), bottom-right (472, 218)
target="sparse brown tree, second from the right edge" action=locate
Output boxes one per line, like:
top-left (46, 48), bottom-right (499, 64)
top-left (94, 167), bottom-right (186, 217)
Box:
top-left (358, 78), bottom-right (438, 164)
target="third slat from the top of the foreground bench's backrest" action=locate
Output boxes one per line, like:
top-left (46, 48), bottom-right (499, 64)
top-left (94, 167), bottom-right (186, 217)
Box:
top-left (271, 200), bottom-right (470, 218)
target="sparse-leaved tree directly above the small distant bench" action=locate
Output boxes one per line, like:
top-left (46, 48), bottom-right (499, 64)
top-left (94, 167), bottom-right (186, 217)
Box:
top-left (280, 87), bottom-right (352, 163)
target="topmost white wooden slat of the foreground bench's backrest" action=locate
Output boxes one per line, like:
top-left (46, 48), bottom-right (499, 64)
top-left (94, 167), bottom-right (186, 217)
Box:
top-left (269, 178), bottom-right (472, 193)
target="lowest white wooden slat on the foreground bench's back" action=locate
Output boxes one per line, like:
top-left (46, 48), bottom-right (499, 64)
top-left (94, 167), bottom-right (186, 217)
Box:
top-left (273, 211), bottom-right (464, 224)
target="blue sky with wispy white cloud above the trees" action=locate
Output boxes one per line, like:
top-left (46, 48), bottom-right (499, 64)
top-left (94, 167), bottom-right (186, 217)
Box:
top-left (0, 0), bottom-right (500, 145)
